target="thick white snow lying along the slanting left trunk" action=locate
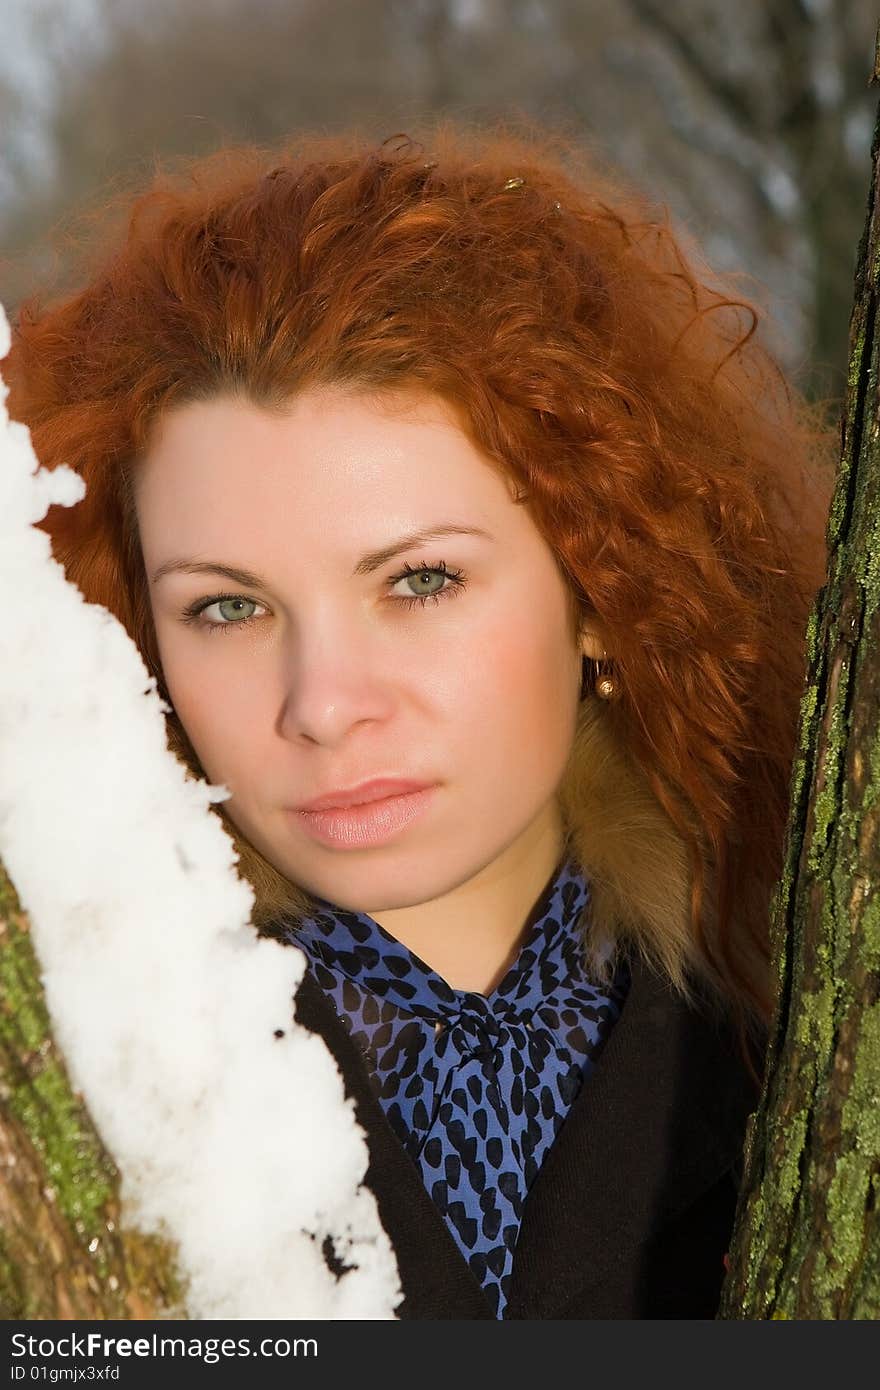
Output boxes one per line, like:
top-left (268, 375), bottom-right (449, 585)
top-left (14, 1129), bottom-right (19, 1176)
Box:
top-left (0, 298), bottom-right (400, 1319)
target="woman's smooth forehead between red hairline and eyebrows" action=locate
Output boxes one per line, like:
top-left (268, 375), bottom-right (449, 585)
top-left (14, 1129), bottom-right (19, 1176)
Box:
top-left (135, 389), bottom-right (521, 528)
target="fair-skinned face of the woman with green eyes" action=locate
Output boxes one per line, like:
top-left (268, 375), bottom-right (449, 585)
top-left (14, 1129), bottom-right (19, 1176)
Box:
top-left (136, 389), bottom-right (598, 912)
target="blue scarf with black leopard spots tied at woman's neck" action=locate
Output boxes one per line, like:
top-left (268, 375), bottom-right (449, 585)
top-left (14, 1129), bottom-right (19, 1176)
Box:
top-left (284, 858), bottom-right (628, 1318)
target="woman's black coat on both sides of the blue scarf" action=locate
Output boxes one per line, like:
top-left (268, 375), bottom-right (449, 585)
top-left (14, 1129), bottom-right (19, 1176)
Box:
top-left (296, 959), bottom-right (758, 1319)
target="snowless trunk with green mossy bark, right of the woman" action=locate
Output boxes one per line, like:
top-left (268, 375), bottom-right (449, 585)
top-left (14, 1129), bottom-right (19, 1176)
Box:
top-left (719, 72), bottom-right (880, 1319)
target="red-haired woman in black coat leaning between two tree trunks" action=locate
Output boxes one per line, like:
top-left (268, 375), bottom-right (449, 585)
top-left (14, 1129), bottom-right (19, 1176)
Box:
top-left (7, 122), bottom-right (830, 1319)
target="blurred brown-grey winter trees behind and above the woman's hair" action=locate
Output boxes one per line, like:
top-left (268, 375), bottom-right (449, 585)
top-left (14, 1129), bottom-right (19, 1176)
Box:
top-left (0, 0), bottom-right (877, 398)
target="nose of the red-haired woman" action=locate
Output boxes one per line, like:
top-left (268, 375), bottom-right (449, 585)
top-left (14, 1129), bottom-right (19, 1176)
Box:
top-left (278, 624), bottom-right (395, 746)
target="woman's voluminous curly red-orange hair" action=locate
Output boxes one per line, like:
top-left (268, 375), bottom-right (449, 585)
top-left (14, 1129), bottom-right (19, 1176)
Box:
top-left (6, 120), bottom-right (833, 1061)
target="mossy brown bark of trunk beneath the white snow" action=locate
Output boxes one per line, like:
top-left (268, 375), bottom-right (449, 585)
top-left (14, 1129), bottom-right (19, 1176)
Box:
top-left (0, 865), bottom-right (185, 1321)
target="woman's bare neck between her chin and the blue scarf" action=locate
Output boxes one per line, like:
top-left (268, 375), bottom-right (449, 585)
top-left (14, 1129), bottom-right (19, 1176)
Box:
top-left (370, 802), bottom-right (563, 994)
